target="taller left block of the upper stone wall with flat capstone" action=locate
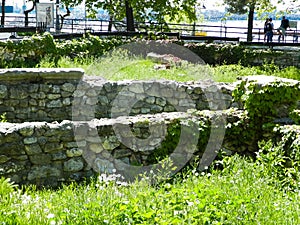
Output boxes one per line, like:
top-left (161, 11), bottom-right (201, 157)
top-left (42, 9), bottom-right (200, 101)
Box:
top-left (0, 69), bottom-right (84, 123)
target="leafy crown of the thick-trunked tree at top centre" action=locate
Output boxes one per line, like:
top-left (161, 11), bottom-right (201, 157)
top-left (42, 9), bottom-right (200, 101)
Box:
top-left (71, 0), bottom-right (197, 31)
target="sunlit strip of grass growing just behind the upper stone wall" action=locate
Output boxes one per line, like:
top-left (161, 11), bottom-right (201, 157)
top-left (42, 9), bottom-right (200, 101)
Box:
top-left (39, 52), bottom-right (300, 82)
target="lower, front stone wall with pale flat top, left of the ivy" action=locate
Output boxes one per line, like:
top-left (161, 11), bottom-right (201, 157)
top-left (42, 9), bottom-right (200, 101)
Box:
top-left (0, 113), bottom-right (223, 187)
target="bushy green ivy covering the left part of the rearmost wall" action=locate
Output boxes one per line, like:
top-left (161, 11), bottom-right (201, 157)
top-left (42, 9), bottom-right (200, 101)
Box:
top-left (0, 33), bottom-right (131, 68)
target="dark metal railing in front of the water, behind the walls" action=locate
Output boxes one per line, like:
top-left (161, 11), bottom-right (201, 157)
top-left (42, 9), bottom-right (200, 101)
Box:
top-left (0, 16), bottom-right (300, 43)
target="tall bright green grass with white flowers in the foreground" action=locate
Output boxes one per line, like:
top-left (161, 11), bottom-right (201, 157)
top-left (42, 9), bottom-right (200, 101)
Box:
top-left (0, 156), bottom-right (300, 225)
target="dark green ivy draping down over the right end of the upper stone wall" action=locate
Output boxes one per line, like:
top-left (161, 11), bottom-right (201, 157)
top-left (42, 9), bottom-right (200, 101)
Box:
top-left (233, 76), bottom-right (300, 149)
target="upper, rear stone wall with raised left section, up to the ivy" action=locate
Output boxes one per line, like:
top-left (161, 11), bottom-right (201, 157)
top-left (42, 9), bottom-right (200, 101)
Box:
top-left (0, 69), bottom-right (233, 123)
